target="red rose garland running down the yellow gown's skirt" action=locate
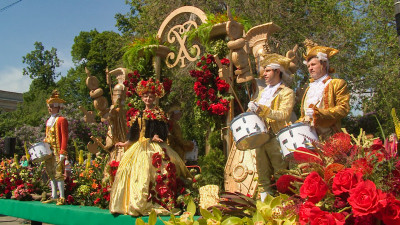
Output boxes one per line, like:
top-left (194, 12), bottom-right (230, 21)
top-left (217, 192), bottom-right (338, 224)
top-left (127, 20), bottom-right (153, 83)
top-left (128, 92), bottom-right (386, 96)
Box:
top-left (148, 148), bottom-right (186, 210)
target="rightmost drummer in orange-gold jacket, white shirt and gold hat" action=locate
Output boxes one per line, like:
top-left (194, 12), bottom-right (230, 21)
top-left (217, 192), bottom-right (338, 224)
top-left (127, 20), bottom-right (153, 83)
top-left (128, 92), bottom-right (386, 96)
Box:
top-left (299, 39), bottom-right (350, 141)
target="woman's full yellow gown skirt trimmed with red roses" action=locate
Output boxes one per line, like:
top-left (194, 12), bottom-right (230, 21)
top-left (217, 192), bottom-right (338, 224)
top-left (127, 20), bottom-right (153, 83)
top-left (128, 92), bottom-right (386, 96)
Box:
top-left (109, 109), bottom-right (190, 216)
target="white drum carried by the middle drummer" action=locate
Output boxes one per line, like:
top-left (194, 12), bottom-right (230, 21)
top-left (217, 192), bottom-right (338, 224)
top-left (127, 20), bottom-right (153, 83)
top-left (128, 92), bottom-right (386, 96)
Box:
top-left (230, 112), bottom-right (269, 150)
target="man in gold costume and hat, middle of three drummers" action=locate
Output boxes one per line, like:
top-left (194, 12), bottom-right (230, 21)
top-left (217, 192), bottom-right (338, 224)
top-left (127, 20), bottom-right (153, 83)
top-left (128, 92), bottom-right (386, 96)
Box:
top-left (248, 54), bottom-right (294, 201)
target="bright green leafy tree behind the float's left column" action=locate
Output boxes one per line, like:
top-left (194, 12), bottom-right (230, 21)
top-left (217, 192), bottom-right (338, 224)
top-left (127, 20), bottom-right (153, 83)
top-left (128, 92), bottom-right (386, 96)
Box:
top-left (70, 30), bottom-right (128, 102)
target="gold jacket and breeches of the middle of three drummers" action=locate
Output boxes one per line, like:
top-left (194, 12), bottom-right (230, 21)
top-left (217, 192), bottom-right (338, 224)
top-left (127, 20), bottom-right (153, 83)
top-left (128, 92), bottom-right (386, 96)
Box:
top-left (256, 84), bottom-right (294, 194)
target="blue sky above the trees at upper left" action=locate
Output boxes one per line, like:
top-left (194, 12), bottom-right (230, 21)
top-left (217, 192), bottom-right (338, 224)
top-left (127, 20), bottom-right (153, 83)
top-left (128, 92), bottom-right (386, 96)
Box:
top-left (0, 0), bottom-right (129, 93)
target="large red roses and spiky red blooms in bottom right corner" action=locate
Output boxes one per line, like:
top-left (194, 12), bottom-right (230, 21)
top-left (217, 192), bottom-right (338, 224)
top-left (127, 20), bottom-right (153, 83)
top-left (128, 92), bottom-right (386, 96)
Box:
top-left (277, 133), bottom-right (400, 225)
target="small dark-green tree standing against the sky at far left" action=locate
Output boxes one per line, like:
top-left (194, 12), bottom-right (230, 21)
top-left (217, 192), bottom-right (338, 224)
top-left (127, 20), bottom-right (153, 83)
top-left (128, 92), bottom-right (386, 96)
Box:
top-left (22, 42), bottom-right (62, 91)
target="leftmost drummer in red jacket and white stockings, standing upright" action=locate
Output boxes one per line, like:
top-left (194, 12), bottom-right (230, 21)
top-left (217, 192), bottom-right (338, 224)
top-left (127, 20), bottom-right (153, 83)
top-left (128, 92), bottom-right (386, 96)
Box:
top-left (43, 90), bottom-right (68, 205)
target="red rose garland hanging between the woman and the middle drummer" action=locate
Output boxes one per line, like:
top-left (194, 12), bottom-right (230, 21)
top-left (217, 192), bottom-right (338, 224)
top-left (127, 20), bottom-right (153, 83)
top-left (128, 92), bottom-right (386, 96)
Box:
top-left (190, 55), bottom-right (230, 116)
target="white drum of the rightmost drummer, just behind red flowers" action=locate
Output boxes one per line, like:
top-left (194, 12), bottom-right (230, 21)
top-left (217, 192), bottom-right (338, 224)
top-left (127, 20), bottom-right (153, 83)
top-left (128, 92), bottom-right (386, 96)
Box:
top-left (276, 123), bottom-right (318, 157)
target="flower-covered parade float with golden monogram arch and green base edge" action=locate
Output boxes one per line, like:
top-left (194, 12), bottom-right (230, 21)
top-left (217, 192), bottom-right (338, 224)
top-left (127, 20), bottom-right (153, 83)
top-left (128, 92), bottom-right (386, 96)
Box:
top-left (0, 6), bottom-right (400, 225)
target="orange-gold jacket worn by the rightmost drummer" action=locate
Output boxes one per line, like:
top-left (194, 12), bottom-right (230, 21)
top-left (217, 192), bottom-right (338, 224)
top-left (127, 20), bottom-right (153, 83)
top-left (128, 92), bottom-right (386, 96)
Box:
top-left (299, 79), bottom-right (350, 140)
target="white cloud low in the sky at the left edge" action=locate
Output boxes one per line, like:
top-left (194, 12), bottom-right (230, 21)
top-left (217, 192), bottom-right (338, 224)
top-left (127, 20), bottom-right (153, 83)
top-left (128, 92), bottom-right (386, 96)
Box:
top-left (0, 67), bottom-right (32, 93)
